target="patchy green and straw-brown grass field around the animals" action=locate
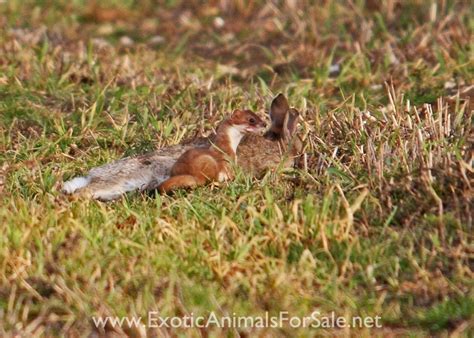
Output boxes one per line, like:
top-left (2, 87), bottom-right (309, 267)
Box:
top-left (0, 0), bottom-right (474, 337)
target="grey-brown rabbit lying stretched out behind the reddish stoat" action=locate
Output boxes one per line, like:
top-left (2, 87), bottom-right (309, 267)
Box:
top-left (62, 94), bottom-right (302, 201)
